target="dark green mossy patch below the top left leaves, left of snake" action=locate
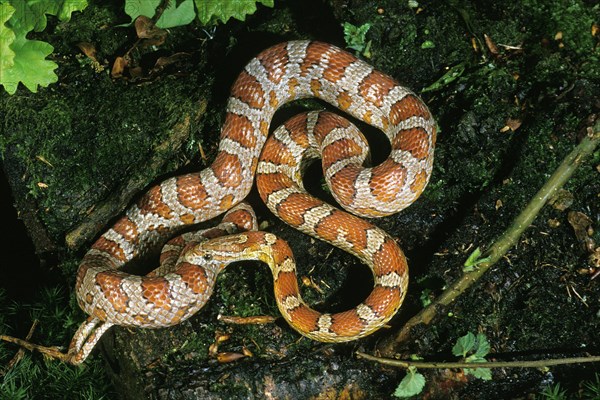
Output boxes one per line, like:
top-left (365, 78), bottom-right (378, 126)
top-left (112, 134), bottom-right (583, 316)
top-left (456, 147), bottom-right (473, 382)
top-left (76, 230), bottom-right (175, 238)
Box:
top-left (3, 79), bottom-right (198, 239)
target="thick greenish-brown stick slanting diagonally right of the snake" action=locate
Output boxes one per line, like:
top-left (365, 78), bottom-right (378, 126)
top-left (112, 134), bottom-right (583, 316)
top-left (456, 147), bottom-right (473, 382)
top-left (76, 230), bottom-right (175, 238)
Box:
top-left (378, 119), bottom-right (600, 355)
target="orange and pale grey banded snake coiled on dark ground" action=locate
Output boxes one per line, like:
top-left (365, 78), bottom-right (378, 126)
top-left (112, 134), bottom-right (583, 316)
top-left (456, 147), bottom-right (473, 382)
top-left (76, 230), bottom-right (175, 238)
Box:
top-left (69, 41), bottom-right (435, 364)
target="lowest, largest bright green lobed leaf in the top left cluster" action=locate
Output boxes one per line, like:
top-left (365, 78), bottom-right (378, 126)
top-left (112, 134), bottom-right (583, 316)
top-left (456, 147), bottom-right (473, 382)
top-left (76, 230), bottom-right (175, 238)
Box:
top-left (0, 37), bottom-right (58, 94)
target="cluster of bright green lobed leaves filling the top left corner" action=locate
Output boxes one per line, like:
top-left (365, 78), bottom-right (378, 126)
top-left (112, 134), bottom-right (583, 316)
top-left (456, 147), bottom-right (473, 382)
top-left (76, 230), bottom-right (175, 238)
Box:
top-left (0, 0), bottom-right (87, 94)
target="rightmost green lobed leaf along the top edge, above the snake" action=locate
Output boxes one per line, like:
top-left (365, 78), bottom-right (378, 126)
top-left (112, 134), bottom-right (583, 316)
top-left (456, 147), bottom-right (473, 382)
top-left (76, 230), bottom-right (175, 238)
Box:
top-left (195, 0), bottom-right (274, 25)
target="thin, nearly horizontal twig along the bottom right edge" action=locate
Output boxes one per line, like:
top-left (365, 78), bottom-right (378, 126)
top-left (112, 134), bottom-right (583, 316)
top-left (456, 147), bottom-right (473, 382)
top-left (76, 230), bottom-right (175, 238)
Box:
top-left (356, 351), bottom-right (600, 369)
